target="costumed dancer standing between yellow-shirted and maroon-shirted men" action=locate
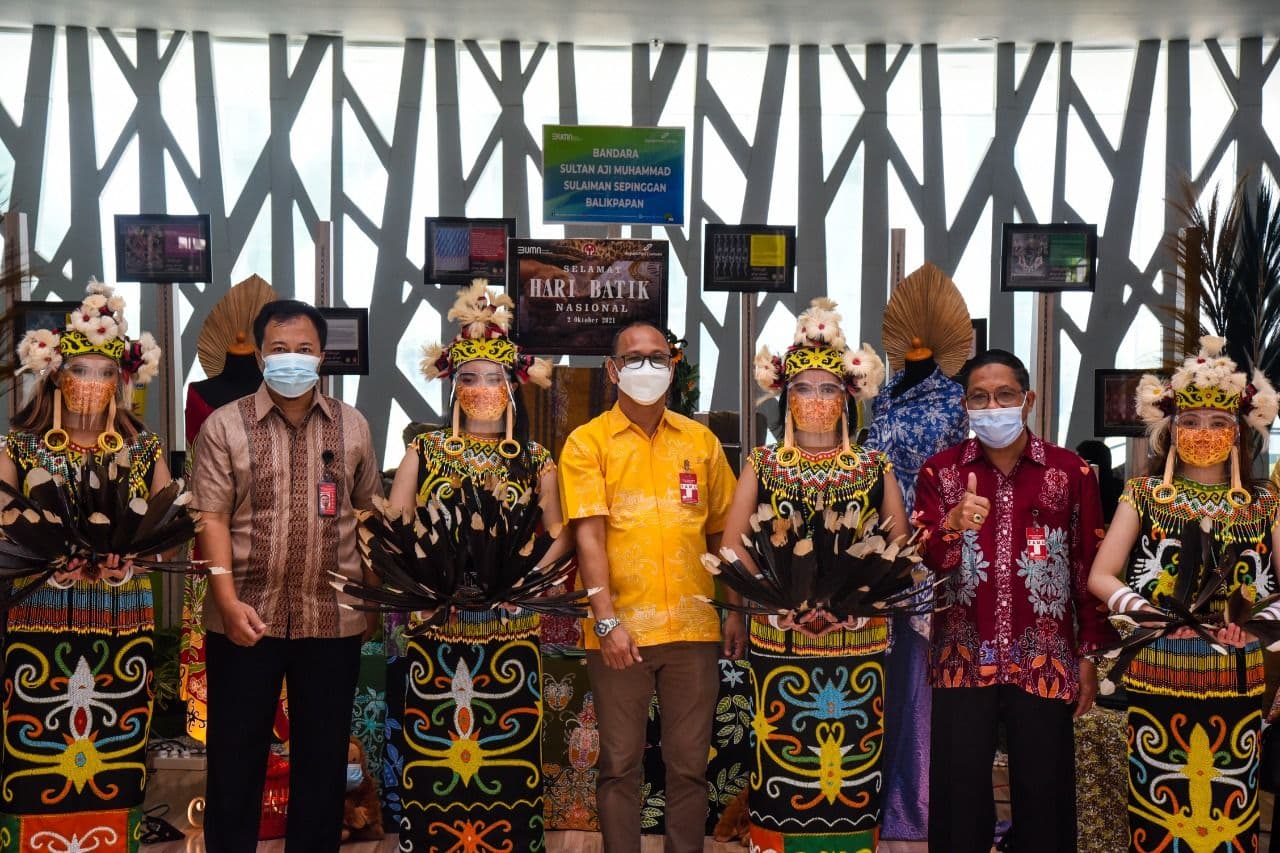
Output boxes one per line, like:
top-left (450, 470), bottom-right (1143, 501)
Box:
top-left (724, 298), bottom-right (911, 853)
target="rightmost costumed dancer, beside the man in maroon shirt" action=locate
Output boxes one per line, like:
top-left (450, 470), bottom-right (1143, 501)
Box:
top-left (1089, 337), bottom-right (1280, 853)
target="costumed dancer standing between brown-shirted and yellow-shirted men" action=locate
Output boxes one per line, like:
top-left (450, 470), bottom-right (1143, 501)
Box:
top-left (346, 279), bottom-right (565, 850)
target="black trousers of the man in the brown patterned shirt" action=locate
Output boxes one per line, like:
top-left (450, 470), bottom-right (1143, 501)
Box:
top-left (205, 631), bottom-right (361, 853)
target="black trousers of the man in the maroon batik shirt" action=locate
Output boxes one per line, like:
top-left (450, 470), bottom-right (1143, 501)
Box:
top-left (929, 684), bottom-right (1075, 853)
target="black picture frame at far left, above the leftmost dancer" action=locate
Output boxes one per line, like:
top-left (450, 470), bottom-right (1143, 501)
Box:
top-left (115, 214), bottom-right (212, 284)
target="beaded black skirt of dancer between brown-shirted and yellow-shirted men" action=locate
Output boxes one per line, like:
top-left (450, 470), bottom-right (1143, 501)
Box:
top-left (399, 612), bottom-right (545, 853)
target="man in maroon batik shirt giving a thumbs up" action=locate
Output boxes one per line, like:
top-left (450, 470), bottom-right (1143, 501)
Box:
top-left (913, 350), bottom-right (1112, 853)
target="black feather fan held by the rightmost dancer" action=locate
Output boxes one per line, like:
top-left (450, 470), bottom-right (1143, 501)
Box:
top-left (1097, 519), bottom-right (1254, 695)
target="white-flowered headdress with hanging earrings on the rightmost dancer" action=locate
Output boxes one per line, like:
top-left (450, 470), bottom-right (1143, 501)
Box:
top-left (1137, 334), bottom-right (1280, 505)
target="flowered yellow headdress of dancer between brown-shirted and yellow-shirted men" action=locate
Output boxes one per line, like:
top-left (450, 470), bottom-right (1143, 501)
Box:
top-left (420, 278), bottom-right (552, 459)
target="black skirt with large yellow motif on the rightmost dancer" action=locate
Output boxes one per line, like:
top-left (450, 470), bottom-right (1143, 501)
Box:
top-left (1128, 688), bottom-right (1262, 853)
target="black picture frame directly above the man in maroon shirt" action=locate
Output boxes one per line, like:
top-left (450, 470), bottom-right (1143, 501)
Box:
top-left (1000, 222), bottom-right (1098, 293)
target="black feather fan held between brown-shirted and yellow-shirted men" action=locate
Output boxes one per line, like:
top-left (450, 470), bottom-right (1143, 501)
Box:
top-left (330, 478), bottom-right (595, 631)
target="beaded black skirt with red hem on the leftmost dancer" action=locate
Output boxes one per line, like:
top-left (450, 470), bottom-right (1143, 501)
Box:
top-left (0, 578), bottom-right (154, 853)
